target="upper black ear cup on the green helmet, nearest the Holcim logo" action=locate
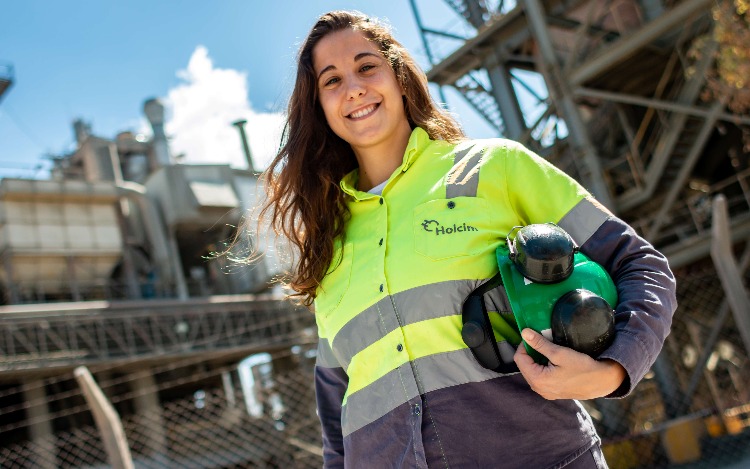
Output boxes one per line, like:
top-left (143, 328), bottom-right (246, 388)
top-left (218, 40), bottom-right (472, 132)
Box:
top-left (508, 223), bottom-right (577, 284)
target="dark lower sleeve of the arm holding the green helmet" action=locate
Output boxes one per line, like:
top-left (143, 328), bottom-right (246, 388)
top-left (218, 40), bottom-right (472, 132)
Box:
top-left (581, 216), bottom-right (677, 397)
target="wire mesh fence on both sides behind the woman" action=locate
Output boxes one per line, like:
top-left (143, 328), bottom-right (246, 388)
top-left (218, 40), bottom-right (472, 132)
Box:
top-left (0, 260), bottom-right (750, 469)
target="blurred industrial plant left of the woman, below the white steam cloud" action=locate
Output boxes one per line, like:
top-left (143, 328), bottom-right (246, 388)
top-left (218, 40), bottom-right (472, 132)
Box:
top-left (0, 99), bottom-right (321, 468)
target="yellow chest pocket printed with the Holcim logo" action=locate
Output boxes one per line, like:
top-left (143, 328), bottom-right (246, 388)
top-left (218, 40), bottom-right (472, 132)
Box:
top-left (413, 197), bottom-right (492, 260)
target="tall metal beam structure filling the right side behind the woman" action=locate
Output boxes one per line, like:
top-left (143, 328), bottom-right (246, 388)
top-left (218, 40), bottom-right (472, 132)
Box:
top-left (411, 0), bottom-right (750, 467)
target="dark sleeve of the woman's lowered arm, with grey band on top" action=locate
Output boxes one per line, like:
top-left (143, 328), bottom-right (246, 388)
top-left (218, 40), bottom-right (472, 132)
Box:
top-left (315, 339), bottom-right (349, 468)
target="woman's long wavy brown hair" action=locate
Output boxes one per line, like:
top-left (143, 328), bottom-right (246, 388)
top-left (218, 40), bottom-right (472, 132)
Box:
top-left (260, 11), bottom-right (464, 306)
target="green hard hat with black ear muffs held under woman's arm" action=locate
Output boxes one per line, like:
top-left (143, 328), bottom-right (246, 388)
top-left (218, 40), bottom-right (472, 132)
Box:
top-left (461, 223), bottom-right (617, 373)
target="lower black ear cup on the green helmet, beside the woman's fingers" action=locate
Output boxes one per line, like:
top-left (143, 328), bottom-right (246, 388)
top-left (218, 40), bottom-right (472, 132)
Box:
top-left (551, 288), bottom-right (615, 358)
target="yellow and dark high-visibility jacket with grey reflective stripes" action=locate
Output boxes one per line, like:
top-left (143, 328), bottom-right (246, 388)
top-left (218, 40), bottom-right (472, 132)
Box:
top-left (315, 128), bottom-right (676, 468)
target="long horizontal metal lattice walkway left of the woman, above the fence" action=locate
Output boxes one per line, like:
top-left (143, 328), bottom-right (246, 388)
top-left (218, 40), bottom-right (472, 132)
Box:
top-left (0, 295), bottom-right (314, 371)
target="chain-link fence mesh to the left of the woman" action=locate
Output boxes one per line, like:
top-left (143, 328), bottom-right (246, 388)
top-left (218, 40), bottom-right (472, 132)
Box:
top-left (0, 344), bottom-right (322, 469)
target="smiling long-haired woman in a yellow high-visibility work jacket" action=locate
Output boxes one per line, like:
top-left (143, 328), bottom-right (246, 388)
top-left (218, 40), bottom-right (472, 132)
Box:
top-left (264, 11), bottom-right (675, 468)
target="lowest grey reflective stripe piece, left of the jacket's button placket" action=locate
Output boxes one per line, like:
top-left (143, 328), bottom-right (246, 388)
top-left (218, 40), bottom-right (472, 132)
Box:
top-left (341, 364), bottom-right (419, 436)
